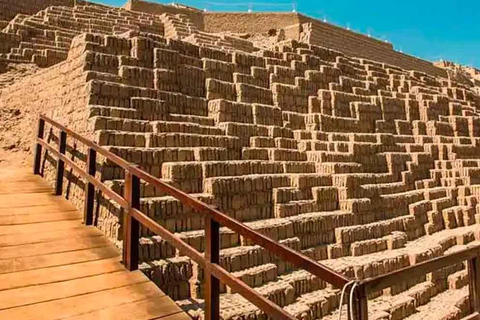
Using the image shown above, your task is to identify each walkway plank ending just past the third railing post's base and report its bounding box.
[0,225,102,247]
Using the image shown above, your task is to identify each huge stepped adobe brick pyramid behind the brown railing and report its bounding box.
[0,1,480,320]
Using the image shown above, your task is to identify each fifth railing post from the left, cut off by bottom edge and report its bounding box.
[205,216,220,320]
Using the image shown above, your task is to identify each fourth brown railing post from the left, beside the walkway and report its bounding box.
[123,170,140,271]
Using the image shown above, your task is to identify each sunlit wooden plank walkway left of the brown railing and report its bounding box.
[0,167,190,320]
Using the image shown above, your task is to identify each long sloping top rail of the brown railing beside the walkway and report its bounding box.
[40,115,350,288]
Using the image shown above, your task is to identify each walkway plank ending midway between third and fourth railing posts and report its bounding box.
[0,237,112,260]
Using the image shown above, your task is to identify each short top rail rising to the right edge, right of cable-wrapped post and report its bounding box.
[361,245,480,292]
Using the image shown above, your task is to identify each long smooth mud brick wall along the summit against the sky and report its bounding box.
[125,0,447,77]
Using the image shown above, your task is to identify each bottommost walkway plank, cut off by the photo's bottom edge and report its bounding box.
[60,296,182,320]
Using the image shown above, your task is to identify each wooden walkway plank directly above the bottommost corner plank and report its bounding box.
[0,282,163,320]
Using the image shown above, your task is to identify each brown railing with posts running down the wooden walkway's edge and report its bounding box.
[34,115,350,320]
